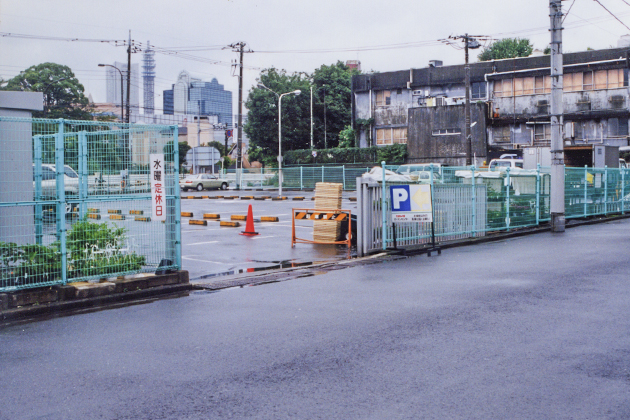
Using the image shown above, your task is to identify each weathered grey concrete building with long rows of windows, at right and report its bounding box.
[352,48,630,165]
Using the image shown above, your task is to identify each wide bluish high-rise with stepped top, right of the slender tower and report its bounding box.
[163,71,232,126]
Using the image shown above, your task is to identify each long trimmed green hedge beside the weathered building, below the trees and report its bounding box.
[283,144,407,165]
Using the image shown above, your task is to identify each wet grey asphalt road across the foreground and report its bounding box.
[0,220,630,420]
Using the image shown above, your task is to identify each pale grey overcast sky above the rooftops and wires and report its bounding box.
[0,0,630,113]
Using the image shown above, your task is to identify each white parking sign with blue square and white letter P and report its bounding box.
[390,184,433,223]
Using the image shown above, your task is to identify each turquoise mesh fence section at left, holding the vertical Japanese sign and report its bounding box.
[0,117,181,291]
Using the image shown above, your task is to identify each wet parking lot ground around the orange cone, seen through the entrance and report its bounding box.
[181,190,357,281]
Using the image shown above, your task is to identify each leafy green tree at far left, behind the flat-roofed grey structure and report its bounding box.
[2,63,92,120]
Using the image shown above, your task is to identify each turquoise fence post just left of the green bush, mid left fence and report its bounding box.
[55,118,68,283]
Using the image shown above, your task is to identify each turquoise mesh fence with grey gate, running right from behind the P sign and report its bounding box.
[358,164,630,255]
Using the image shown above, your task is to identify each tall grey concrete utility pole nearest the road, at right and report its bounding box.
[549,0,565,232]
